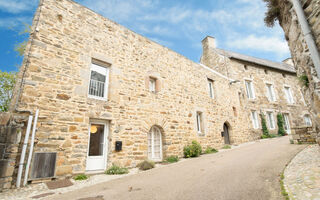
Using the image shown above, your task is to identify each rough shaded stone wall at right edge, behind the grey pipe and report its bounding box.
[279,0,320,144]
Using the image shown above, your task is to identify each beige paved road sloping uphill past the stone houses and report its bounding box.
[50,137,305,200]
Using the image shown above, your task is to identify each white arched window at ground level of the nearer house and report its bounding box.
[148,126,162,161]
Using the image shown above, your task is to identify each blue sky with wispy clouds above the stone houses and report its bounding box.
[0,0,290,71]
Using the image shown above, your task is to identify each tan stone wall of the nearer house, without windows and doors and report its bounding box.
[10,0,252,176]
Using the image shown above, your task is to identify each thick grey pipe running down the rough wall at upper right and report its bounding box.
[291,0,320,78]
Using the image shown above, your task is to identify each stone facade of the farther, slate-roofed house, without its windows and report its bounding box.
[201,40,309,136]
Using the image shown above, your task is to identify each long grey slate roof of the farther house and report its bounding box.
[212,48,296,73]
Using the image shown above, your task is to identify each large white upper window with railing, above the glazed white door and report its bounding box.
[89,63,109,99]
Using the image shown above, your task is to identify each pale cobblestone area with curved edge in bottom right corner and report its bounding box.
[284,145,320,200]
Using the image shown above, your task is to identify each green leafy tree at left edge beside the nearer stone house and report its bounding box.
[0,70,16,112]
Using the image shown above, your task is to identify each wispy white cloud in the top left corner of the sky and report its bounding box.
[0,0,38,14]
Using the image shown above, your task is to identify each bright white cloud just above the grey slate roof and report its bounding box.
[227,34,289,57]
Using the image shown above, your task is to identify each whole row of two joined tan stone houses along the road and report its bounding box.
[1,0,308,189]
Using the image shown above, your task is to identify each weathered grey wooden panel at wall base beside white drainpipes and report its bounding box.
[31,152,57,179]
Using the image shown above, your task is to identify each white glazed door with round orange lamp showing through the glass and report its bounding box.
[86,123,108,170]
